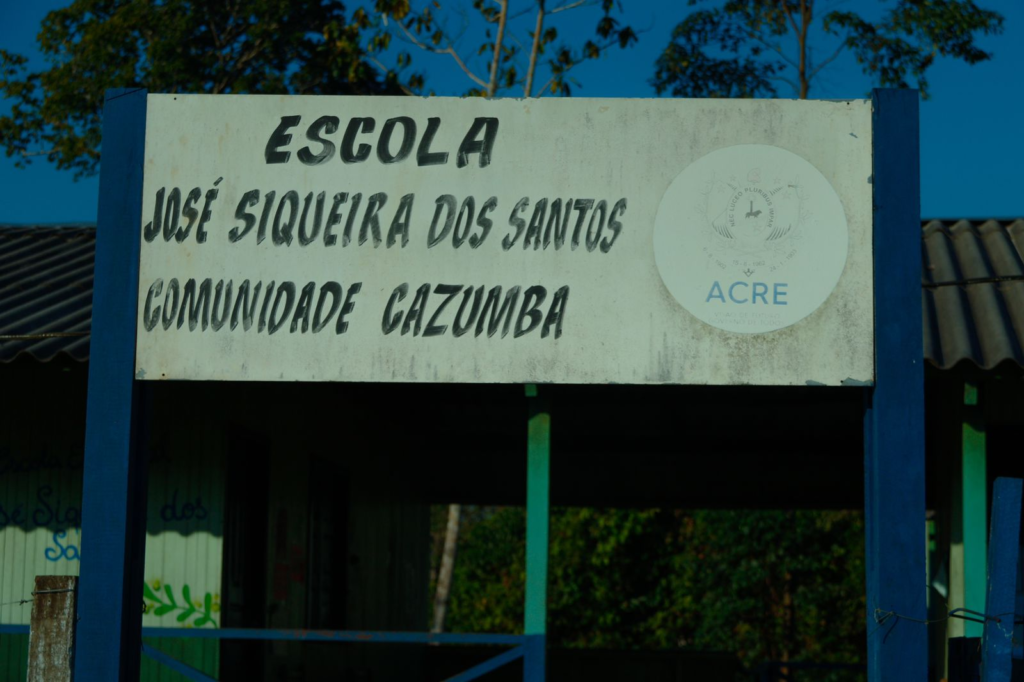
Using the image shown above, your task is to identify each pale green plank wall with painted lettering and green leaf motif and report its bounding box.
[0,374,224,682]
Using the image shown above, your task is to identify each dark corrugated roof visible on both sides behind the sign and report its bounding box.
[0,219,1024,370]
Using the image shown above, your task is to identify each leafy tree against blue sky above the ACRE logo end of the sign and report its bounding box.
[651,0,1002,99]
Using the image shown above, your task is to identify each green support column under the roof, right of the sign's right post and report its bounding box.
[961,382,988,637]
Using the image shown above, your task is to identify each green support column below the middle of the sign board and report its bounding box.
[523,385,551,682]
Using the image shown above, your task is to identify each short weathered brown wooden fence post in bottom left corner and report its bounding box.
[29,576,78,682]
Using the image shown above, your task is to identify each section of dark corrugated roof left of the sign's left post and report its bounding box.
[0,226,96,363]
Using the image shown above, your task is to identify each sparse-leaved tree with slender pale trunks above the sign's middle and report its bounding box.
[372,0,637,97]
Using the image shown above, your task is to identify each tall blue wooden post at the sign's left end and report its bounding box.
[75,88,146,682]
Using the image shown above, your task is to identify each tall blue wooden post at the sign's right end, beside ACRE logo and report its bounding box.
[864,89,928,682]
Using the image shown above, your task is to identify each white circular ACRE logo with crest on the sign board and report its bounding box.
[654,144,849,334]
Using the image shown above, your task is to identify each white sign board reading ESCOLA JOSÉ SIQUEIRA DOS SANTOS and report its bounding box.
[136,95,874,386]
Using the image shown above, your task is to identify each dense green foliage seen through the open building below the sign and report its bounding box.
[436,508,864,668]
